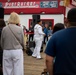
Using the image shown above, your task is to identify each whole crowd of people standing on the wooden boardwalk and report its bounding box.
[0,8,76,75]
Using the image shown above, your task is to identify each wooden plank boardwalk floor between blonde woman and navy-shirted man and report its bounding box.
[24,45,45,75]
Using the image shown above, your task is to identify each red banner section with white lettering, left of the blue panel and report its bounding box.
[2,2,40,8]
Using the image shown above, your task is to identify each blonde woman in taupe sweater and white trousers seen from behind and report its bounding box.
[1,12,24,75]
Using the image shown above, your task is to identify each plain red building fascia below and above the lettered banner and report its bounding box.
[0,0,65,14]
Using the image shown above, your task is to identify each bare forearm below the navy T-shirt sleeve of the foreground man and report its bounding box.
[46,54,54,75]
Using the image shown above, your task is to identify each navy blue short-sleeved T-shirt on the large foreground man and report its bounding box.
[45,27,76,75]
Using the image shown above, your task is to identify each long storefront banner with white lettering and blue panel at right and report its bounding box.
[2,0,58,9]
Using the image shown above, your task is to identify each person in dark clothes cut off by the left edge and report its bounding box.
[0,19,6,75]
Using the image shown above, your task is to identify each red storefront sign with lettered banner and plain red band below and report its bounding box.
[0,0,65,14]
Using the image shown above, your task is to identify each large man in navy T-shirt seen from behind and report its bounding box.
[45,8,76,75]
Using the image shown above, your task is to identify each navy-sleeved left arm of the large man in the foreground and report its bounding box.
[45,36,56,75]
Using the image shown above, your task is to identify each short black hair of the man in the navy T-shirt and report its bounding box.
[67,8,76,22]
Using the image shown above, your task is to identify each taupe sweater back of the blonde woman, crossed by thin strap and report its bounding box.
[2,24,23,50]
